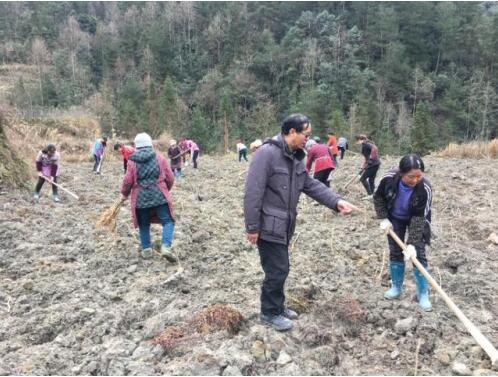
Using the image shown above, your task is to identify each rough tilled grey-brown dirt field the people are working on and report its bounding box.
[0,154,498,375]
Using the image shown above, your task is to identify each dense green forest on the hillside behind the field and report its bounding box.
[0,2,498,154]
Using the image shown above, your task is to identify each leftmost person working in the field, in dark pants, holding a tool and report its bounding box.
[33,144,60,203]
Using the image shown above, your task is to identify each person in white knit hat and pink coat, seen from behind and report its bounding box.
[121,133,178,262]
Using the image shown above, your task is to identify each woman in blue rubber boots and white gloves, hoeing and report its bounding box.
[374,154,432,311]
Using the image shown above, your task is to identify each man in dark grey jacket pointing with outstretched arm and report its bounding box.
[244,114,357,331]
